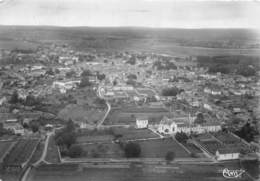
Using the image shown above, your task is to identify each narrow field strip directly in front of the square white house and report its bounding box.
[113,128,159,141]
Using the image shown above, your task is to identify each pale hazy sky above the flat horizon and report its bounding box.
[0,0,260,29]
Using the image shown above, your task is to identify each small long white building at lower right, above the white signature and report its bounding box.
[216,148,240,161]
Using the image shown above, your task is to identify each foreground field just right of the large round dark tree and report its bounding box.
[133,138,189,158]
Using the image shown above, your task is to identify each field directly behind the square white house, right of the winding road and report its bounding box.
[104,107,170,125]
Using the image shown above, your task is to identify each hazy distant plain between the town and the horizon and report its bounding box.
[0,26,260,55]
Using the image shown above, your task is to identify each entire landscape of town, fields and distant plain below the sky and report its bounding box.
[0,0,260,181]
